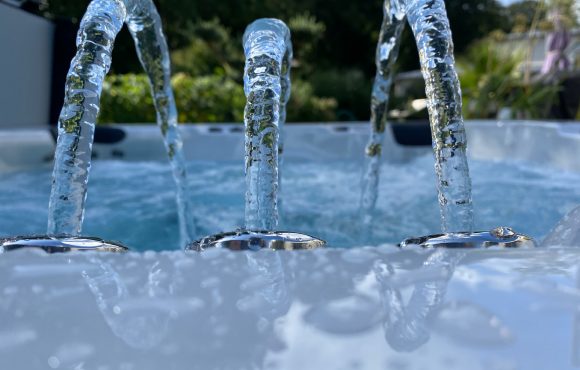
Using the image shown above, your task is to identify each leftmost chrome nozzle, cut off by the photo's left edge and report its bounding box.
[0,235,129,253]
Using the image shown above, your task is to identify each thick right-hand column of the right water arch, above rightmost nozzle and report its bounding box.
[407,0,473,232]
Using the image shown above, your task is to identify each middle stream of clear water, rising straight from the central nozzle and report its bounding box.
[243,19,292,230]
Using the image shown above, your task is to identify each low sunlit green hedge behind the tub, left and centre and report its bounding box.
[99,73,337,123]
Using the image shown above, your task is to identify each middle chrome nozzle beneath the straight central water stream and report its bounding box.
[186,229,326,252]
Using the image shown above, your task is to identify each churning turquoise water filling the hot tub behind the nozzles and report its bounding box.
[0,155,580,250]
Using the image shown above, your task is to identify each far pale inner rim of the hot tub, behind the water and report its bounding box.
[0,120,580,172]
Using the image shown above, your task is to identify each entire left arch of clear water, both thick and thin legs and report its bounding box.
[48,0,195,249]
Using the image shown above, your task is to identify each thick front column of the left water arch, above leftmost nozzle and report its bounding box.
[48,1,127,235]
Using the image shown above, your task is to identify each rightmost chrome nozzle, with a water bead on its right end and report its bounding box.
[399,226,537,249]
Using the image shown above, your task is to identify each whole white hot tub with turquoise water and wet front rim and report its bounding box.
[0,121,580,370]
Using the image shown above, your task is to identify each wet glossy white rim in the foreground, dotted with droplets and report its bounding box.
[0,246,580,370]
